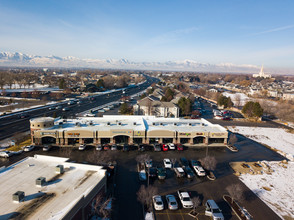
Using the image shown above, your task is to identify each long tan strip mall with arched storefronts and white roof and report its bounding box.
[30,115,228,146]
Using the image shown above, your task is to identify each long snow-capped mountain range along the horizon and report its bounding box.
[0,52,259,73]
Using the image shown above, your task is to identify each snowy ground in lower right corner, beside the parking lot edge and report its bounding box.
[240,162,294,219]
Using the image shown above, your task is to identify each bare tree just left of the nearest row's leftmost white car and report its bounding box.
[137,185,158,211]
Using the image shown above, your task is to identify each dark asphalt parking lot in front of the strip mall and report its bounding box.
[0,135,284,220]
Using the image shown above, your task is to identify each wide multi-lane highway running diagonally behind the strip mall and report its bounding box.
[0,76,158,140]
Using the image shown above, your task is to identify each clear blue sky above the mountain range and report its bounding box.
[0,0,294,68]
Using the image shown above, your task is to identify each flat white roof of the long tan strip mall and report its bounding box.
[39,115,227,133]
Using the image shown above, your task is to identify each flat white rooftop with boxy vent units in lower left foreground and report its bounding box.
[0,155,105,219]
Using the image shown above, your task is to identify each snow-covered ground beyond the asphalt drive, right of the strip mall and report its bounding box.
[228,126,294,161]
